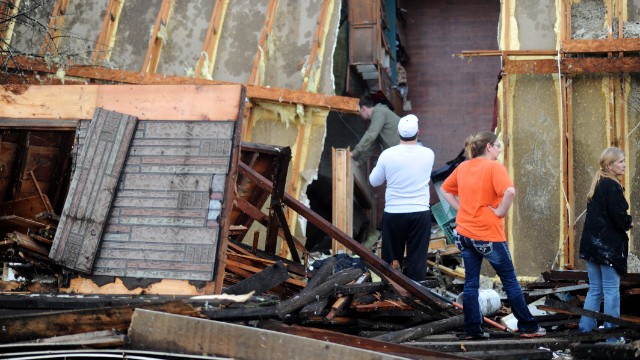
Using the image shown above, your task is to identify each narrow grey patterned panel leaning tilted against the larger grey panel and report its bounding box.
[49,109,137,273]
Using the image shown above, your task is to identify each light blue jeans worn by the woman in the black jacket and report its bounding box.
[578,261,620,332]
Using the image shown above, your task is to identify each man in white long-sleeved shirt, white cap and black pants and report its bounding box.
[369,115,435,281]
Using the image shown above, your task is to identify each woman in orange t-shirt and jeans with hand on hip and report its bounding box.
[442,132,546,339]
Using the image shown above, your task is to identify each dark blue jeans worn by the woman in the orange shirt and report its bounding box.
[454,234,538,335]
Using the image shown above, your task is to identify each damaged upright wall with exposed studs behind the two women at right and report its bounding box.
[499,0,640,276]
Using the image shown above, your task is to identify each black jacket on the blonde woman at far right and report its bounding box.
[580,178,631,275]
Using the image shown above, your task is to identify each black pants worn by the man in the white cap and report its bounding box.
[382,210,431,281]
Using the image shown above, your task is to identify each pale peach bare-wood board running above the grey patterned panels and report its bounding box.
[0,85,243,121]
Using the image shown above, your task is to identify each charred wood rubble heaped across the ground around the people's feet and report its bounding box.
[0,116,640,359]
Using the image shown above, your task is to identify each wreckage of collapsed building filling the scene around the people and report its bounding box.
[0,0,640,359]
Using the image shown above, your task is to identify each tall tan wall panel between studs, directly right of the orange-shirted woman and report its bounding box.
[508,75,562,275]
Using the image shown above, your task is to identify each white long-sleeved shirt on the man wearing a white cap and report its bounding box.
[369,144,435,213]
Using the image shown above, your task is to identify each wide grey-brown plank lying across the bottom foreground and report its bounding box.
[129,309,408,360]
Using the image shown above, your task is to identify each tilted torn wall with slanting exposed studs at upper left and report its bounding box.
[0,0,357,262]
